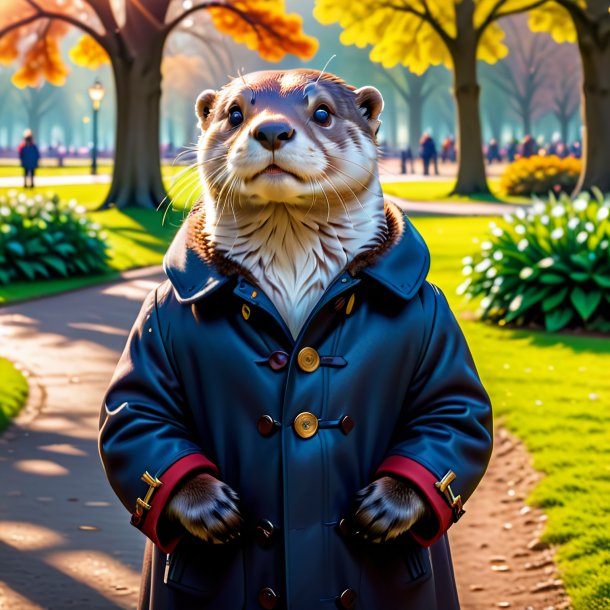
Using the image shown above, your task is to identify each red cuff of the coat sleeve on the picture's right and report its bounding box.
[376,455,453,546]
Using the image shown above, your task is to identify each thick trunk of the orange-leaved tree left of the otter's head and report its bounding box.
[102,45,165,209]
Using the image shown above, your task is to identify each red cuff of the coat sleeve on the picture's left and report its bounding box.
[131,453,218,553]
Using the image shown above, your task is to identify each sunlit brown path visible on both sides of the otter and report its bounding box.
[0,269,567,610]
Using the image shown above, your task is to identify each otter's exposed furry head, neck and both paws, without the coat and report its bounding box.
[167,70,428,543]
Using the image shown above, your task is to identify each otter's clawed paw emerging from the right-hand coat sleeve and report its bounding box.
[351,477,429,542]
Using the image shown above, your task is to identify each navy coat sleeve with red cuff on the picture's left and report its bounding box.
[99,284,218,552]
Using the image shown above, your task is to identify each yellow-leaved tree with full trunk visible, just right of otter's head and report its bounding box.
[314,0,547,195]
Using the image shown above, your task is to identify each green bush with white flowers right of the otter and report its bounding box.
[458,190,610,332]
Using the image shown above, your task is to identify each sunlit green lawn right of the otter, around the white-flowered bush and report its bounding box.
[414,218,610,610]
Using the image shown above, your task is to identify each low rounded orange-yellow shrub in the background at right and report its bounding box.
[500,155,582,197]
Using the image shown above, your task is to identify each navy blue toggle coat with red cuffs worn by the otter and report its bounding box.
[100,206,492,610]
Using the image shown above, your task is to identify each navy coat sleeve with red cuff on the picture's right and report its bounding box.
[377,283,493,546]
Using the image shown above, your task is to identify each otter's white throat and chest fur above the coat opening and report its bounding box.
[206,201,387,337]
